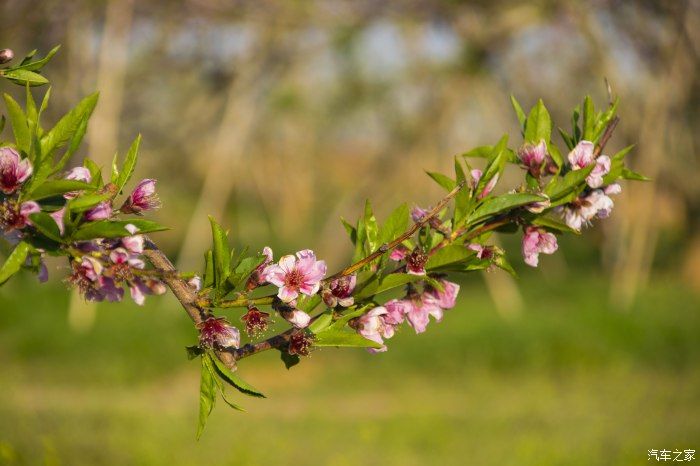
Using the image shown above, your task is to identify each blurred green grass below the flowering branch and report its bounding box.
[0,271,700,465]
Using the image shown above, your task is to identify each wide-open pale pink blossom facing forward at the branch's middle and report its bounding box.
[262,249,326,303]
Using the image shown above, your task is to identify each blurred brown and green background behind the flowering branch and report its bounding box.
[0,0,700,465]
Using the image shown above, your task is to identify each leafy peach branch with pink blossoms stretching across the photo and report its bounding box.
[0,49,645,437]
